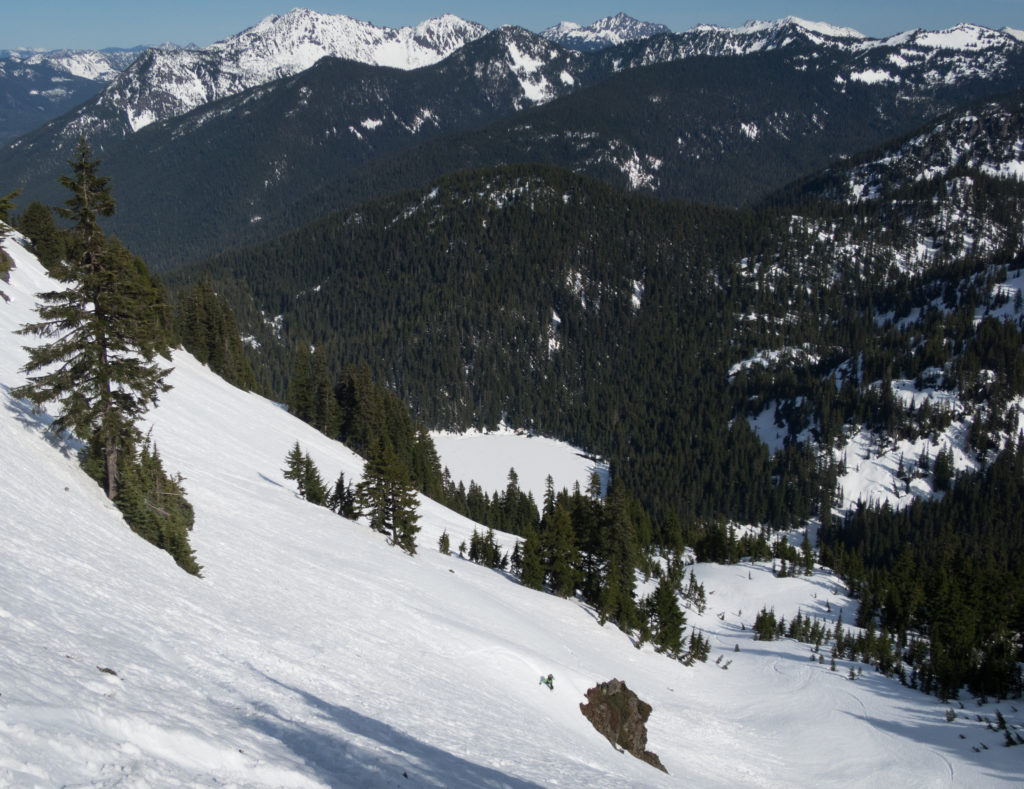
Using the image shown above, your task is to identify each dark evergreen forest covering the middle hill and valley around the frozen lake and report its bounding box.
[163,136,1024,695]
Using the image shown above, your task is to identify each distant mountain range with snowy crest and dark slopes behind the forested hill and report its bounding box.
[0,10,1024,268]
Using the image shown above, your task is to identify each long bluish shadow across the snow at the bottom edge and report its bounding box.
[243,669,541,789]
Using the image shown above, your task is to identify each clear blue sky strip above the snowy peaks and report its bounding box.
[6,0,1024,49]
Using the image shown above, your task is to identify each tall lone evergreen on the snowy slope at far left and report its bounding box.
[13,140,169,499]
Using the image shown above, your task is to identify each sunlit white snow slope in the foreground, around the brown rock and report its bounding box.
[0,240,1024,789]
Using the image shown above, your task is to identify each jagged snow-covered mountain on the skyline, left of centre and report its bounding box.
[76,9,486,136]
